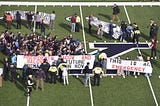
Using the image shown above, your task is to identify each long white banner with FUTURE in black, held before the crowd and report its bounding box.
[17,55,95,69]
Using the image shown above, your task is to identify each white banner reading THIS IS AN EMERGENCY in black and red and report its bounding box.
[107,58,152,73]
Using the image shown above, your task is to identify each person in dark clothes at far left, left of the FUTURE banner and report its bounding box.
[3,57,9,81]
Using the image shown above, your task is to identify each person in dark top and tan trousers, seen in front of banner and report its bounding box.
[36,68,46,91]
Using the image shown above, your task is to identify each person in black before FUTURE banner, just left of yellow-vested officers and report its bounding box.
[40,58,50,82]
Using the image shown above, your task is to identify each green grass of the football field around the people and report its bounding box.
[0,0,160,106]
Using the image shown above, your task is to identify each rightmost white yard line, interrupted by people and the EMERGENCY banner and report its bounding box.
[124,6,158,106]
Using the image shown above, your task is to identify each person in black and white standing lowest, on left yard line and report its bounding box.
[26,75,34,96]
